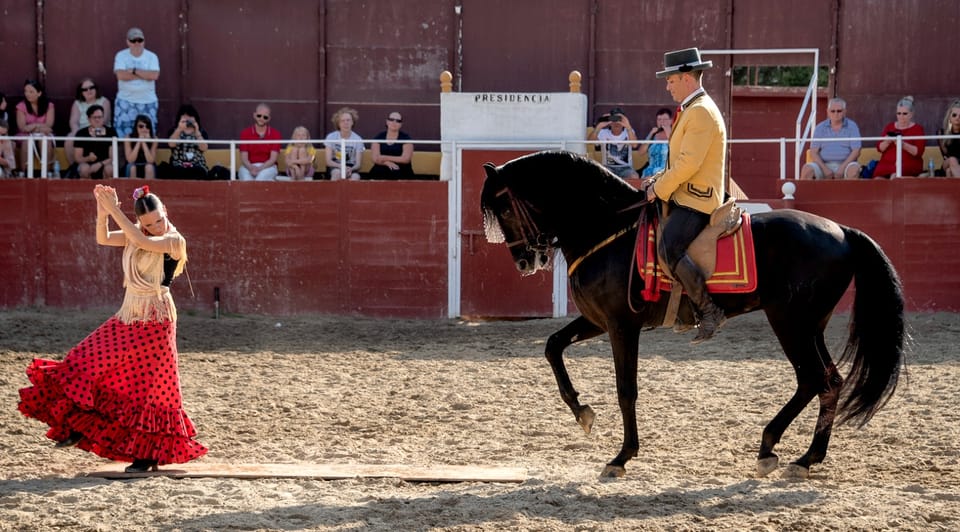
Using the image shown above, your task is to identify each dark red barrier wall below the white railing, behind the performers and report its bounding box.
[0,179,960,318]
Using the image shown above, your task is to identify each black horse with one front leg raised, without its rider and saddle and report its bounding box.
[481,152,904,477]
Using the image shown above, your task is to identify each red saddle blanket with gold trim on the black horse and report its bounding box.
[637,212,757,301]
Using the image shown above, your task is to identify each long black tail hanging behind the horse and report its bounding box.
[837,227,905,426]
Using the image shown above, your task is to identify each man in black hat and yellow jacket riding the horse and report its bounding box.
[641,48,727,344]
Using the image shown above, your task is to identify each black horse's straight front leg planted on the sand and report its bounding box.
[601,326,640,477]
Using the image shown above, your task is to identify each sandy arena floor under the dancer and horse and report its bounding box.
[0,310,960,532]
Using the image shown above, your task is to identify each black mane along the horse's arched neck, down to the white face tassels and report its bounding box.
[481,151,643,243]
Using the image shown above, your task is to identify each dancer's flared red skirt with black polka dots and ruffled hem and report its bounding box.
[19,317,207,465]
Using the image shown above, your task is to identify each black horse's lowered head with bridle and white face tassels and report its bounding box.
[480,163,556,275]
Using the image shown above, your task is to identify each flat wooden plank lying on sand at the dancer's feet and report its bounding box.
[81,462,527,482]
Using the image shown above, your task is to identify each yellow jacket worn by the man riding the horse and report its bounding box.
[653,93,727,214]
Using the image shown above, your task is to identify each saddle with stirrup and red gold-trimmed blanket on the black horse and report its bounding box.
[636,199,757,331]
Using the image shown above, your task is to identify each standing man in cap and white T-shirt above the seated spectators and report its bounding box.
[113,28,160,138]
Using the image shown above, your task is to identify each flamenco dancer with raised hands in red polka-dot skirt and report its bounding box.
[19,185,207,473]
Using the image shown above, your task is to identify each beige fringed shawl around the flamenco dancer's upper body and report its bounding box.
[116,224,187,323]
